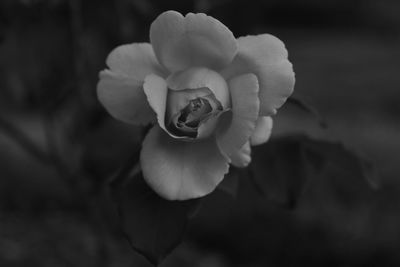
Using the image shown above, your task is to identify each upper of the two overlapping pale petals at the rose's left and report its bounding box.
[106,43,167,81]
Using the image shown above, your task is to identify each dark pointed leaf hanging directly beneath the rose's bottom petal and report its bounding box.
[114,174,200,266]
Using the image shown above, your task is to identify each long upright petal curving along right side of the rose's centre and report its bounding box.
[217,74,260,161]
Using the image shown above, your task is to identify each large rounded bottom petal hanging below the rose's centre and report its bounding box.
[140,126,229,200]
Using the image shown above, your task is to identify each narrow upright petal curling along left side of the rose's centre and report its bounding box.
[143,74,168,132]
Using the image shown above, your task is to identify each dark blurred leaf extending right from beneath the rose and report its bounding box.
[251,136,378,208]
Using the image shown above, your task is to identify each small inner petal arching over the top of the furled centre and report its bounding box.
[167,67,230,109]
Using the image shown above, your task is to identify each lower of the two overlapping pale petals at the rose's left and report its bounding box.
[97,70,155,124]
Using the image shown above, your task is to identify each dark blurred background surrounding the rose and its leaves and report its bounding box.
[0,0,400,267]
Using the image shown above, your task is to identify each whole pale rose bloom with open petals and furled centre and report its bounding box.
[97,11,295,200]
